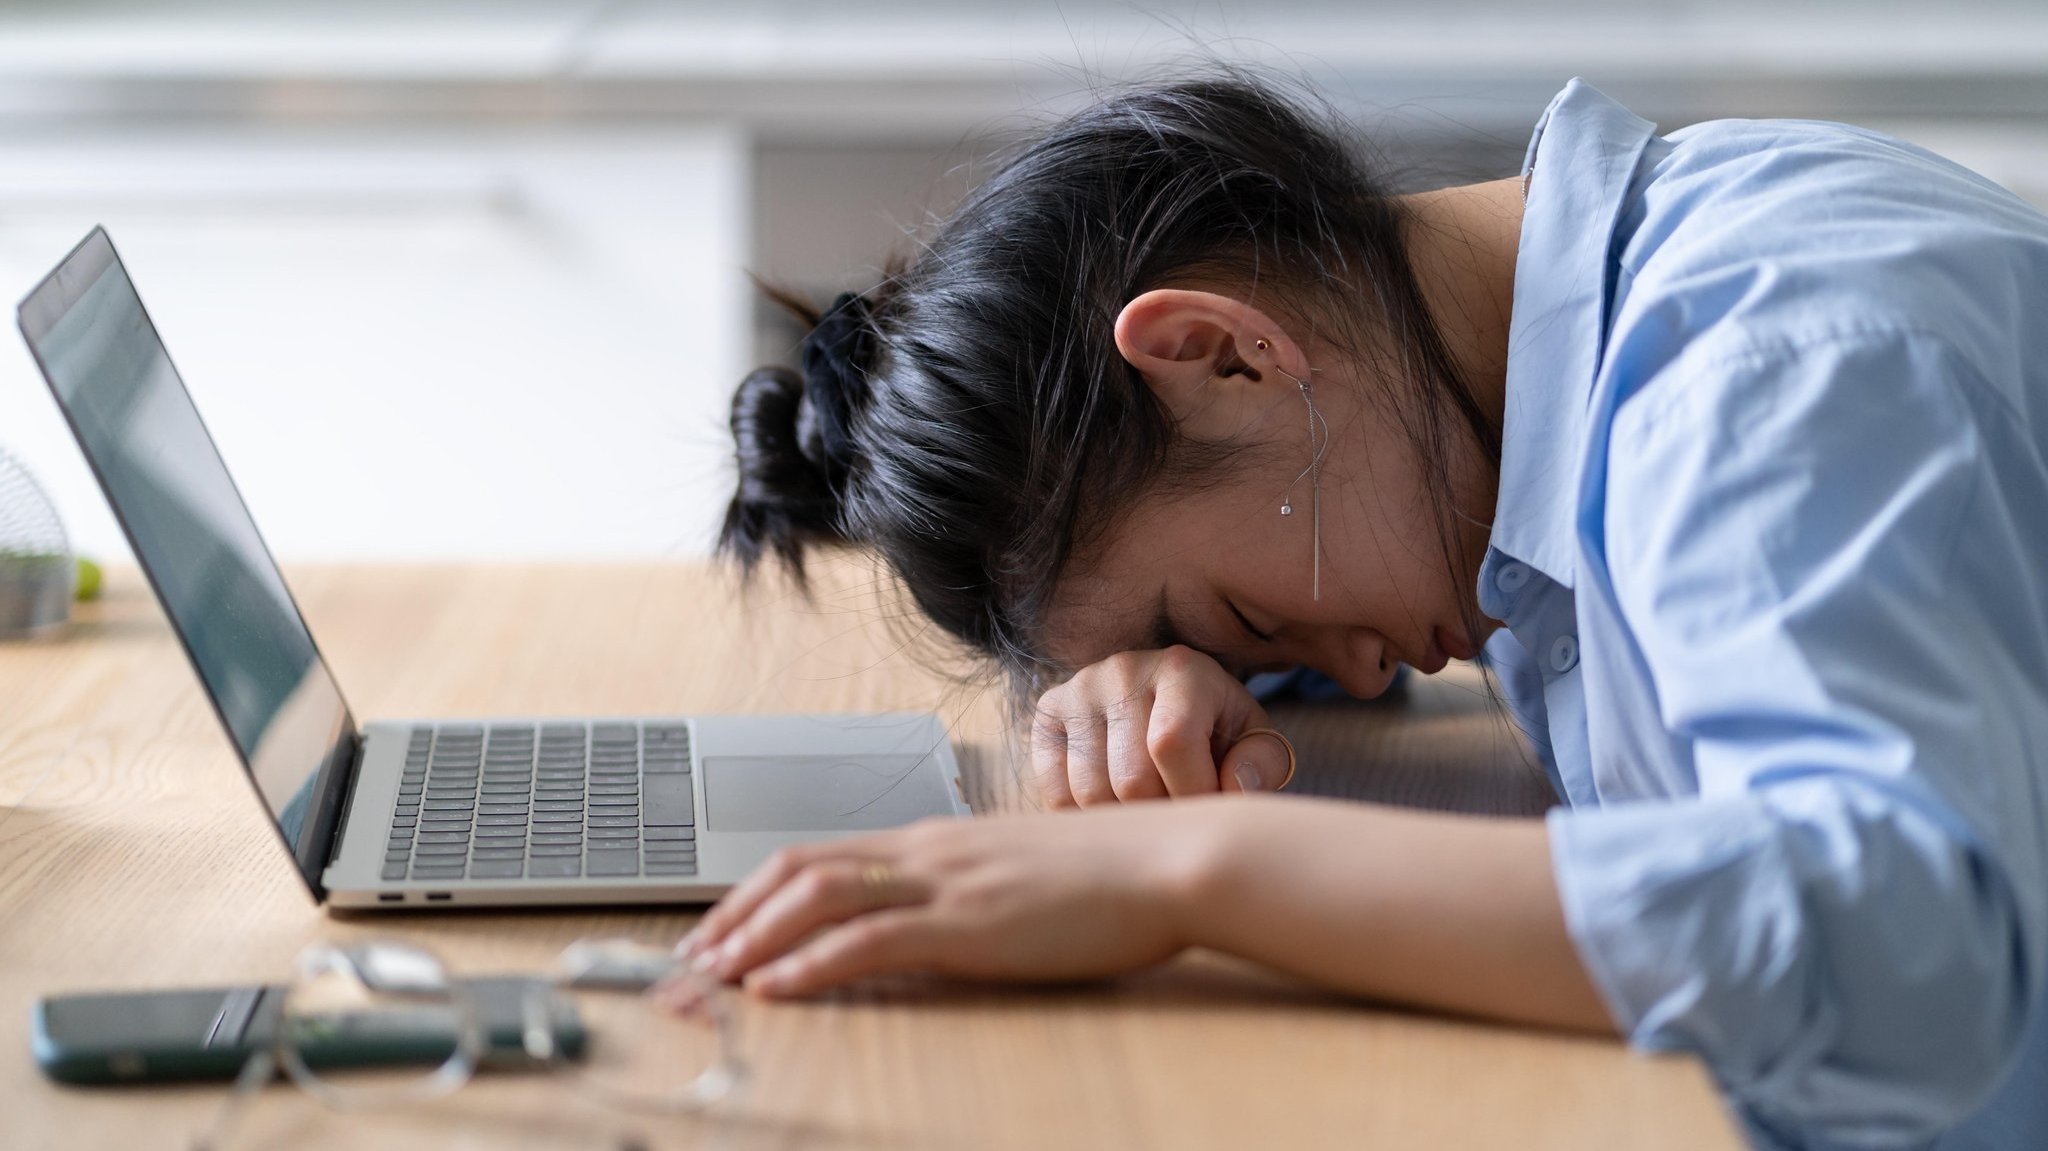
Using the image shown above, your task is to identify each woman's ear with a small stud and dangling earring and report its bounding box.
[1116,289,1307,438]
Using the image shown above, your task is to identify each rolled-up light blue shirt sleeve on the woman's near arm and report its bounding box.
[1550,332,2048,1147]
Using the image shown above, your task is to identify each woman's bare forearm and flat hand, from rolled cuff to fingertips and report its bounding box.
[657,797,1614,1034]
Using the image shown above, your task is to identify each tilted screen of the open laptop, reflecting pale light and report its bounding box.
[20,229,354,897]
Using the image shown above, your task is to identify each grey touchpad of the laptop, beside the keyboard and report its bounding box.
[705,756,952,832]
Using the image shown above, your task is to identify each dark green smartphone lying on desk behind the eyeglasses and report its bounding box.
[29,975,584,1083]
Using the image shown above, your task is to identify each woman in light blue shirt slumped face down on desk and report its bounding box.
[688,80,2048,1149]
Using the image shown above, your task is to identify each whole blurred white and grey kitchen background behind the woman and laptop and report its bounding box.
[0,0,2048,559]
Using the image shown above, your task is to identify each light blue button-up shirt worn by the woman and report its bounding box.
[1479,82,2048,1151]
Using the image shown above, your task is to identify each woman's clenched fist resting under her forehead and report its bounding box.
[1032,647,1288,807]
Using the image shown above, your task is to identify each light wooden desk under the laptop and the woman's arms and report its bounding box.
[0,565,1741,1151]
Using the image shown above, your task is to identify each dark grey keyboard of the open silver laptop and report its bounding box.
[383,723,696,881]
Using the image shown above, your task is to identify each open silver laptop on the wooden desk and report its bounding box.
[16,227,969,909]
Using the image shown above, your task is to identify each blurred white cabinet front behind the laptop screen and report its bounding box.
[0,125,748,557]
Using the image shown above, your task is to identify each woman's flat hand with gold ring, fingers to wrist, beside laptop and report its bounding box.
[667,803,1212,995]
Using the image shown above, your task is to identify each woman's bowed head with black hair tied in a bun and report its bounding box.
[719,78,1497,690]
